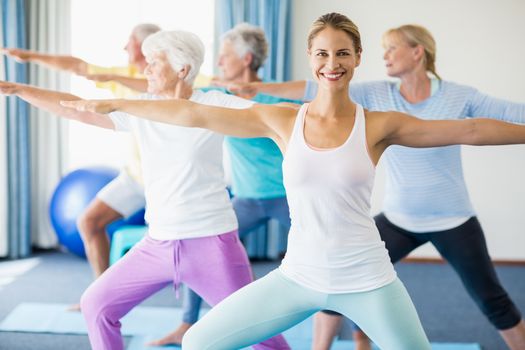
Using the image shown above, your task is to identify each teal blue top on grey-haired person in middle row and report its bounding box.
[203,88,302,199]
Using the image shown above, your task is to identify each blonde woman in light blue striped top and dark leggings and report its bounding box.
[304,25,525,350]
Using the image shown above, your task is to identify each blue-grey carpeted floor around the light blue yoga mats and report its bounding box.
[0,251,525,350]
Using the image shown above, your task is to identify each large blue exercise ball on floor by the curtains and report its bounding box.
[49,167,144,258]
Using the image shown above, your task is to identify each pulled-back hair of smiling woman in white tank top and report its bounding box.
[308,12,363,54]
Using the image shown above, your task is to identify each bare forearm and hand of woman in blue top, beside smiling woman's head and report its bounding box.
[212,80,306,100]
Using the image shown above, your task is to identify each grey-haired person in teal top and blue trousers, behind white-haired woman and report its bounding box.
[150,23,300,346]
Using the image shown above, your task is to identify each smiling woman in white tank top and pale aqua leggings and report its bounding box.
[59,13,525,350]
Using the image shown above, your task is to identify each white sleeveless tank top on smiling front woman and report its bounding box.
[279,104,396,293]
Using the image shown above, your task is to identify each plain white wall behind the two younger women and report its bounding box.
[292,0,525,261]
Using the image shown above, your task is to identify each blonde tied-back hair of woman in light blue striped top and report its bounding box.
[383,24,441,80]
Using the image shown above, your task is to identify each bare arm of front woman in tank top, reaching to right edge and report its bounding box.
[376,112,525,147]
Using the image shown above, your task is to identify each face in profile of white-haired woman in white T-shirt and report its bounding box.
[144,52,181,95]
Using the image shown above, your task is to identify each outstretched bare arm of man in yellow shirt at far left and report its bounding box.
[1,48,88,75]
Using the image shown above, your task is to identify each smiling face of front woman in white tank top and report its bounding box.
[308,26,361,90]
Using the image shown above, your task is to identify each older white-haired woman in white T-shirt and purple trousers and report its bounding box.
[0,31,289,350]
